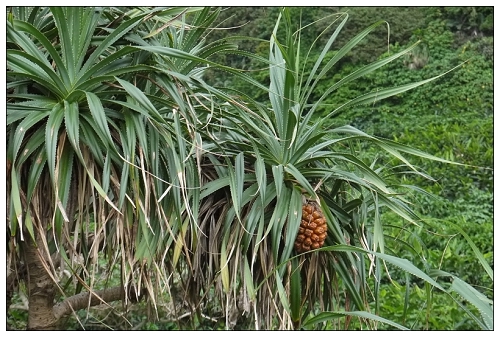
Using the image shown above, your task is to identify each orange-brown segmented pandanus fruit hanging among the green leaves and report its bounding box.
[295,201,327,253]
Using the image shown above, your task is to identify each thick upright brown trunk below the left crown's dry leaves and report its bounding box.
[24,235,57,330]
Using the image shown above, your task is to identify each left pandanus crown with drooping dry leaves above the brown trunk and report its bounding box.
[7,7,264,329]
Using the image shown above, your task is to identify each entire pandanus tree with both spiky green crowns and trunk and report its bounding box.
[7,7,491,329]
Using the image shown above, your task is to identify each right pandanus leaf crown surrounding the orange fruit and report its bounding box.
[177,9,491,329]
